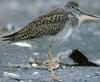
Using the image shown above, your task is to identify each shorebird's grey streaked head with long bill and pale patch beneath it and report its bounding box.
[66,0,98,22]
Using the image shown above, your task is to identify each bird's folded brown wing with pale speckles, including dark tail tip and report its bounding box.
[2,9,68,42]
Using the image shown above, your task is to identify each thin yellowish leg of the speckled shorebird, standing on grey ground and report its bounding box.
[48,45,58,80]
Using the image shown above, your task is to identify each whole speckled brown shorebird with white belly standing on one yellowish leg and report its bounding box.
[2,1,97,80]
